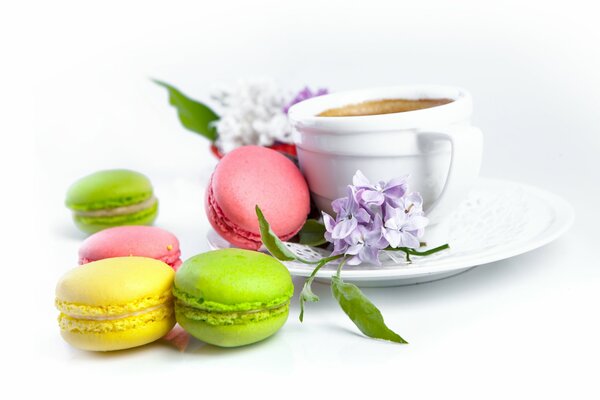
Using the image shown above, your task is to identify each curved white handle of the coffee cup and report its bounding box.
[419,126,483,223]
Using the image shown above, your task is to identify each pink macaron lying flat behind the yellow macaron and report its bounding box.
[79,225,181,270]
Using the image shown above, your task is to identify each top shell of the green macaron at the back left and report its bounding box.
[65,169,153,211]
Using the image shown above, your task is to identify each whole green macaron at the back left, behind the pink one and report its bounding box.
[65,169,158,233]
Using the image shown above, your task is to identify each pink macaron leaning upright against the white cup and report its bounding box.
[205,146,310,250]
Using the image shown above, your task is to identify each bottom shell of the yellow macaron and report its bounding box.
[60,314,175,351]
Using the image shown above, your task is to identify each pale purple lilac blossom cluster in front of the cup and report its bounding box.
[323,171,429,265]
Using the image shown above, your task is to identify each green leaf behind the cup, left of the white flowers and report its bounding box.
[154,80,219,142]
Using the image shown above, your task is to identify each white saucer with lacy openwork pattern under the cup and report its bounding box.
[208,178,574,287]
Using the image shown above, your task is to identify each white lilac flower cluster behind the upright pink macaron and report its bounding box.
[211,79,291,154]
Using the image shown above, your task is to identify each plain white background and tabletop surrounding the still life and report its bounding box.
[5,0,600,398]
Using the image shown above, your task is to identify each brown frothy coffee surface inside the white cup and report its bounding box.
[318,99,453,117]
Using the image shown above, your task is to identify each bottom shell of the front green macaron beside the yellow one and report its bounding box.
[175,308,289,347]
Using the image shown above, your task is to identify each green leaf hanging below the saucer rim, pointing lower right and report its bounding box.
[331,276,408,343]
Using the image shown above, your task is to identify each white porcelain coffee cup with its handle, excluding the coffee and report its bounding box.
[288,85,482,244]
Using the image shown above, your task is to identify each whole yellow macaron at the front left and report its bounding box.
[55,257,175,351]
